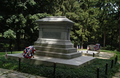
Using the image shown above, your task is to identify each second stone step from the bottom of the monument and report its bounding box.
[34,46,77,53]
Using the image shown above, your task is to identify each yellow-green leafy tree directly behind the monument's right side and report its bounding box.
[53,0,99,45]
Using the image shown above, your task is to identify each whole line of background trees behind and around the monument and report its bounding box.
[0,0,120,51]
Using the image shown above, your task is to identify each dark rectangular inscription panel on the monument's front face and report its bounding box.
[42,31,61,39]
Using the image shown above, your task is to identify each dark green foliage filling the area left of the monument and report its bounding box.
[0,0,51,49]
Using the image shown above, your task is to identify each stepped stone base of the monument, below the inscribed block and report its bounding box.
[34,38,81,59]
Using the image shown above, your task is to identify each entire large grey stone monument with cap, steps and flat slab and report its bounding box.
[7,16,95,68]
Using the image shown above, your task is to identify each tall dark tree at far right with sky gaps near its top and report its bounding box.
[96,0,116,49]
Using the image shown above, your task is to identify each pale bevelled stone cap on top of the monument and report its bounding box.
[36,16,74,24]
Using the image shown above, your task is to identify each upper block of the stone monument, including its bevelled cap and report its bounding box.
[36,16,74,40]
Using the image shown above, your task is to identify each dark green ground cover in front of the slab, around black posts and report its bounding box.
[0,51,120,78]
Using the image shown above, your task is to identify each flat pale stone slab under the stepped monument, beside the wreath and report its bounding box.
[8,53,95,68]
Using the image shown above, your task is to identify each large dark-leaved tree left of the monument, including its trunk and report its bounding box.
[1,0,47,50]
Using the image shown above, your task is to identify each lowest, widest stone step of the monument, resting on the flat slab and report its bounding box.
[35,51,82,59]
